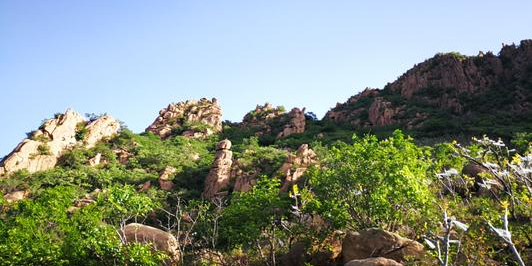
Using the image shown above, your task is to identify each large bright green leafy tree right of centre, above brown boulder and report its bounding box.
[309,131,433,230]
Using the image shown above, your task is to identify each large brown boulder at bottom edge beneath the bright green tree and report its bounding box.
[342,228,425,263]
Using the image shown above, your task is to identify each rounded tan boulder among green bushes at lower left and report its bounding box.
[121,223,179,261]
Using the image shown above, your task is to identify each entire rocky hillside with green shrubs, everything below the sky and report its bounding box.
[0,41,532,266]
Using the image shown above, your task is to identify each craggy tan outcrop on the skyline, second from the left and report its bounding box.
[146,98,222,139]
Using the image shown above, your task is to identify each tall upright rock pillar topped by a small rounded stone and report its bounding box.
[202,139,233,199]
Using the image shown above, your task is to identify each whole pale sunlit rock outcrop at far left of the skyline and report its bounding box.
[0,110,120,177]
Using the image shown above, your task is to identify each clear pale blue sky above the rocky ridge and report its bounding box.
[0,0,532,157]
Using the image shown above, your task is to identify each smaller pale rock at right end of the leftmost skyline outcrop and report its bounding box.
[84,115,120,148]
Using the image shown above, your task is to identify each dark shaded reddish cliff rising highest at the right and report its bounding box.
[325,40,532,135]
